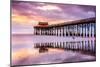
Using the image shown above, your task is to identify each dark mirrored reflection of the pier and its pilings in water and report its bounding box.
[34,40,96,54]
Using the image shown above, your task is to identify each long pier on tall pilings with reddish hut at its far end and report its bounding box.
[34,17,96,37]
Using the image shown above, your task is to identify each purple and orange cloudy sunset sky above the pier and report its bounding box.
[11,1,96,34]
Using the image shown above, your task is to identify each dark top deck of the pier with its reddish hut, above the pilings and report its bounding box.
[34,17,96,28]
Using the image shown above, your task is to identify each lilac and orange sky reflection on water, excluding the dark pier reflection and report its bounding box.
[12,35,95,65]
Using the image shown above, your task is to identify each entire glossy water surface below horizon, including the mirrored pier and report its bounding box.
[12,35,96,66]
